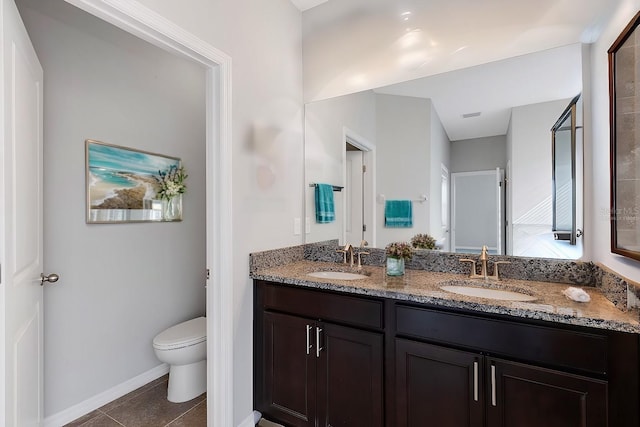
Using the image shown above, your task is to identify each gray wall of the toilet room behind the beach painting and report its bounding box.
[18,0,206,416]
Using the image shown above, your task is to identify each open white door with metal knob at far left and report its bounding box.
[0,0,44,427]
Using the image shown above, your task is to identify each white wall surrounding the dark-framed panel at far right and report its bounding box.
[585,0,640,281]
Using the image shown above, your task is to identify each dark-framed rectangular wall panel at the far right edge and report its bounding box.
[608,12,640,260]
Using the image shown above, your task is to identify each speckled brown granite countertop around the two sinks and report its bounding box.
[251,261,640,334]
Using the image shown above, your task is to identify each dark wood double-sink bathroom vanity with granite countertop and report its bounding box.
[252,261,640,427]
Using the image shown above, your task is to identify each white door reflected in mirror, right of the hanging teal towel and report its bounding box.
[344,151,364,246]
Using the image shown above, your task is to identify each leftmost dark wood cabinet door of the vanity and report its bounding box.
[260,312,316,427]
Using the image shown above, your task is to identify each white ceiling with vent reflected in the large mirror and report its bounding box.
[375,43,582,141]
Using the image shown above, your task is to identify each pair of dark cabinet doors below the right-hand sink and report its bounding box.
[396,339,607,427]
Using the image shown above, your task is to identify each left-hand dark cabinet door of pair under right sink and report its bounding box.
[395,339,484,427]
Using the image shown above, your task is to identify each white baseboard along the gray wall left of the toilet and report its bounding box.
[44,363,169,427]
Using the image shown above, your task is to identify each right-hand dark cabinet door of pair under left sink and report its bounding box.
[317,323,384,427]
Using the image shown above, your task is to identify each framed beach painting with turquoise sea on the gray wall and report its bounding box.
[85,139,182,223]
